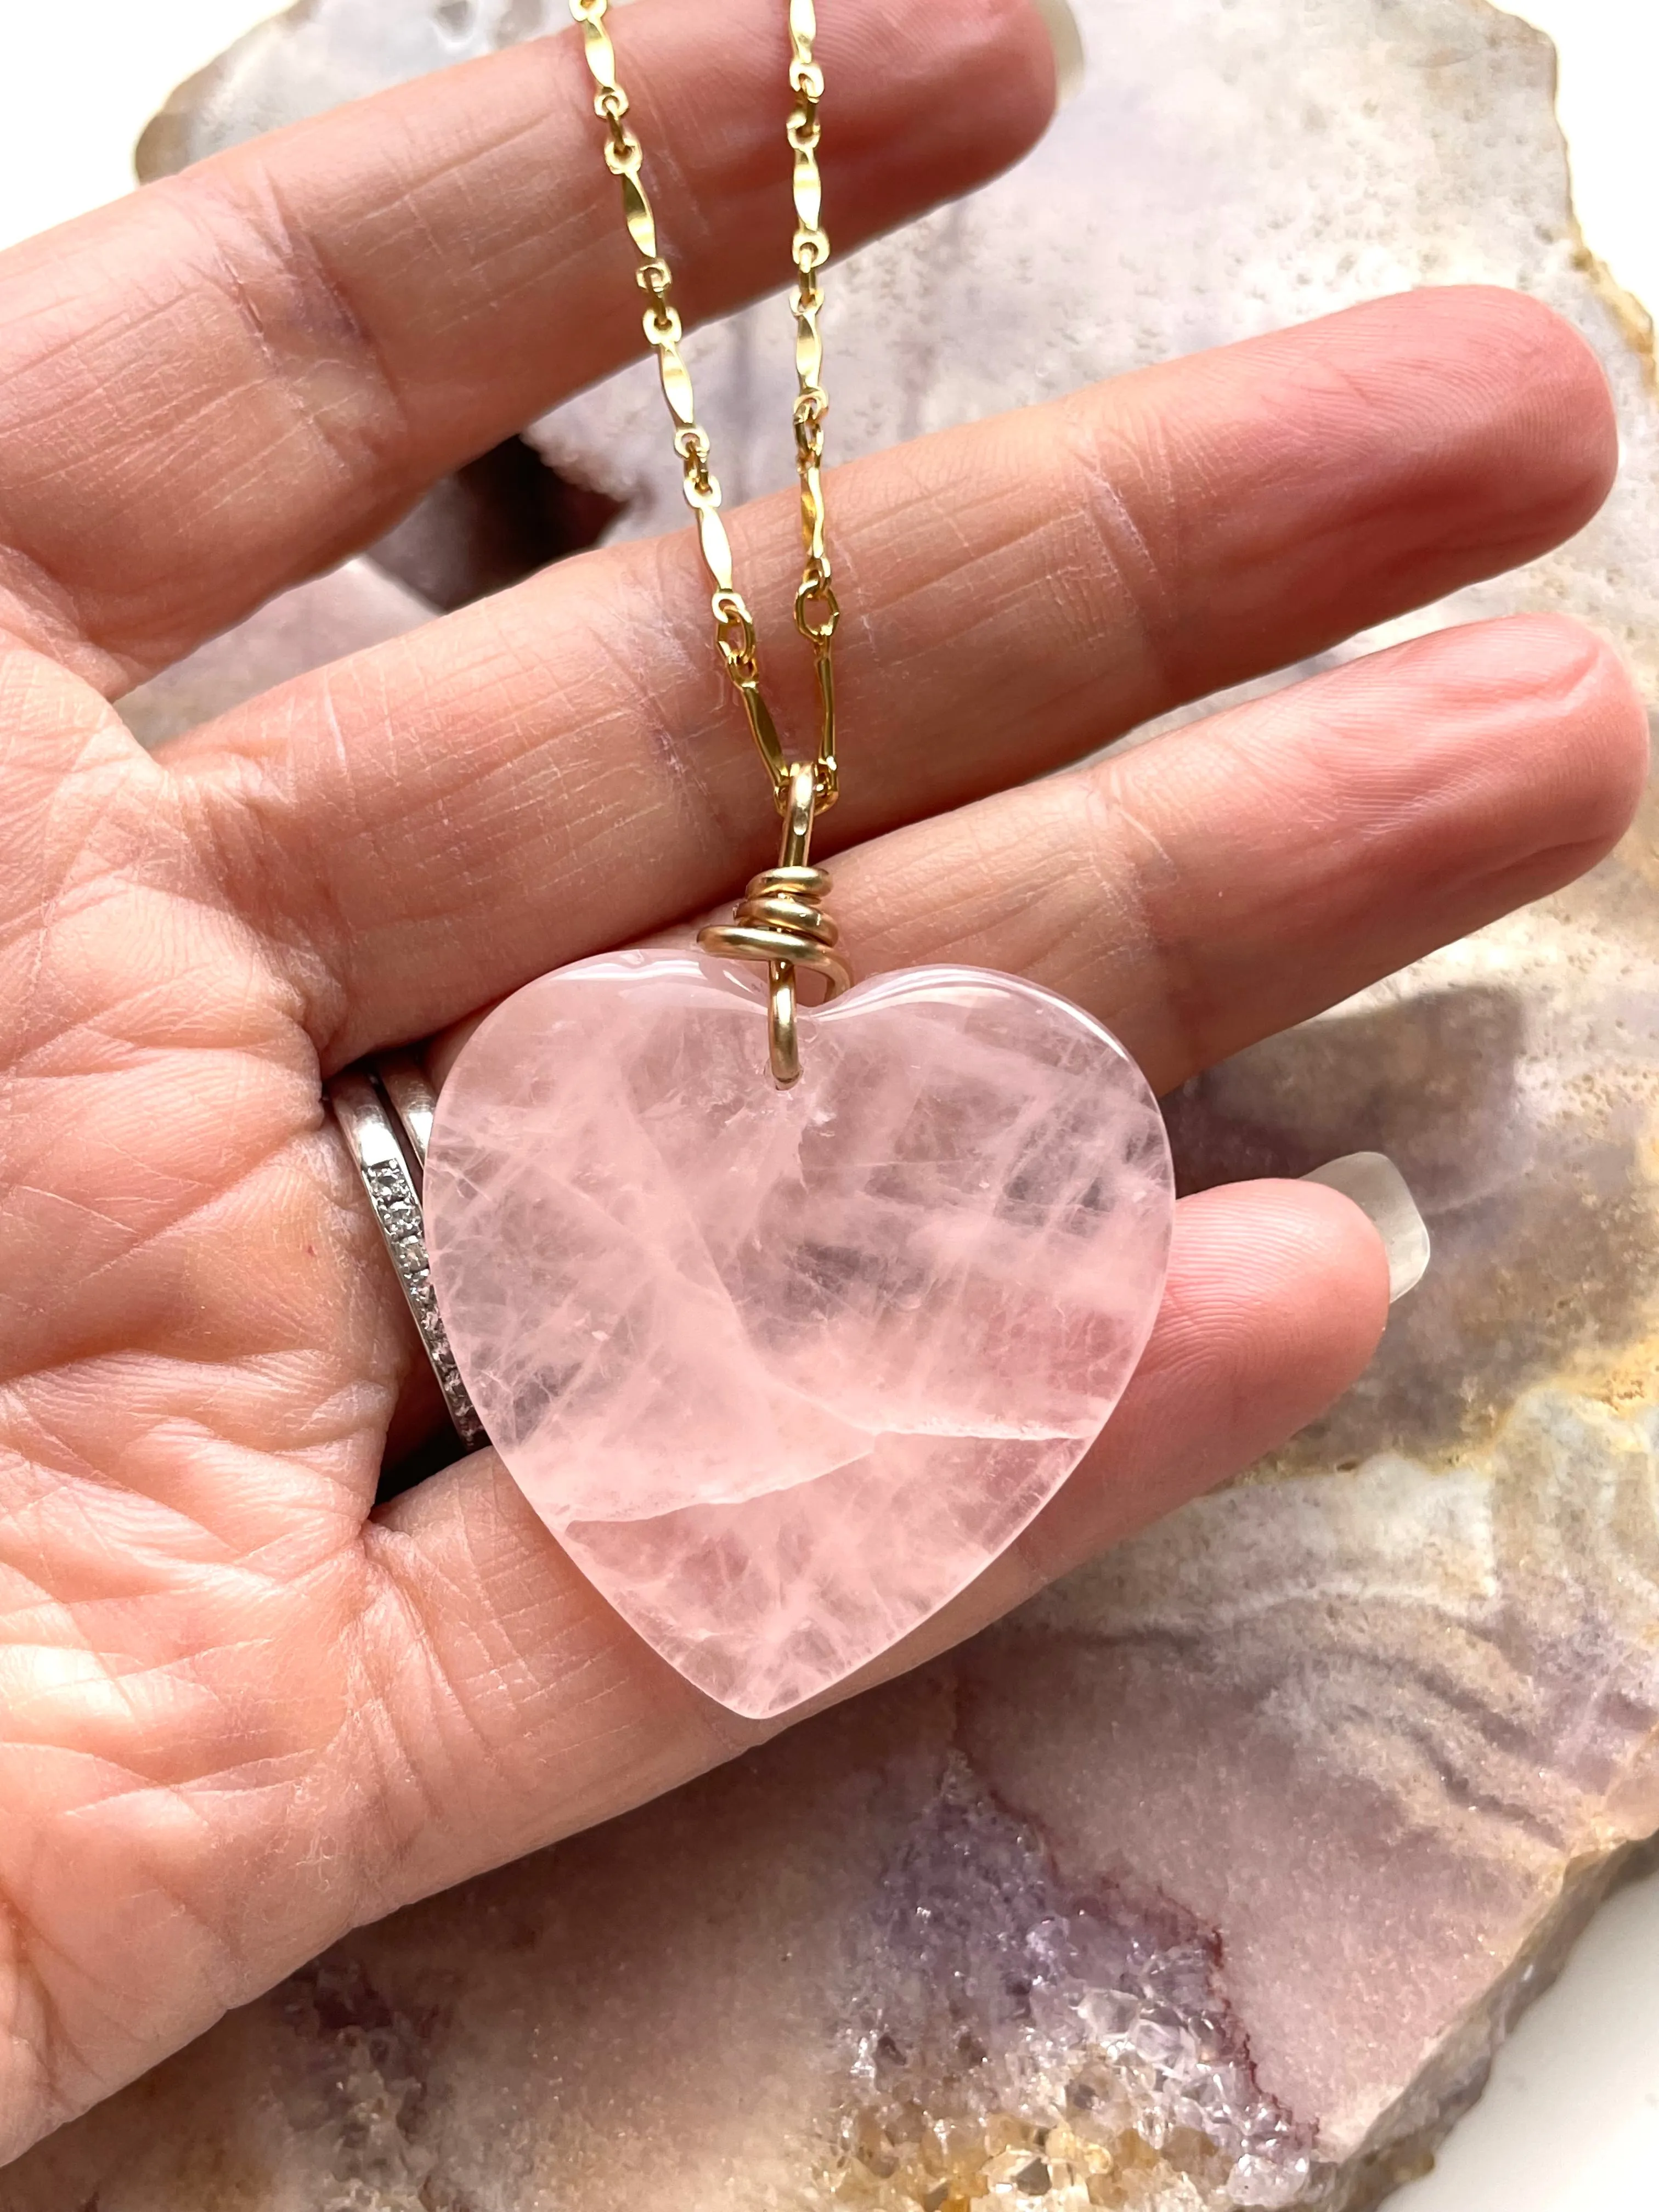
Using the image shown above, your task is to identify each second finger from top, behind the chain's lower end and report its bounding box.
[181,292,1612,1059]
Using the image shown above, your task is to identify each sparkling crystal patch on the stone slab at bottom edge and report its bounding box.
[825,1758,1314,2212]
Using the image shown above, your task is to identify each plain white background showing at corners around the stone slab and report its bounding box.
[0,0,1659,2212]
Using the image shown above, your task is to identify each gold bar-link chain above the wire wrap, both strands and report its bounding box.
[571,0,840,814]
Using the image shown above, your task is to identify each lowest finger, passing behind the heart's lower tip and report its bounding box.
[341,1183,1387,1914]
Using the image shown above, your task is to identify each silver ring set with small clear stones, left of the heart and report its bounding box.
[323,1053,489,1451]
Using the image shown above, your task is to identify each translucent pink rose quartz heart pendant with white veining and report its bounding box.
[425,951,1175,1717]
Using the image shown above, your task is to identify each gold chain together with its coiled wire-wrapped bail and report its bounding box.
[571,0,851,1086]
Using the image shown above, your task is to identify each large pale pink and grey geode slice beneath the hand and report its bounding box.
[16,0,1659,2212]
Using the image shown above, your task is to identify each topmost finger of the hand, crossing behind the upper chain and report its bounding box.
[0,0,1053,688]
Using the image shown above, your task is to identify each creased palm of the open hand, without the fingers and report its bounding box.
[0,648,398,2117]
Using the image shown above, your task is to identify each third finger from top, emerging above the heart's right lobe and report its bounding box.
[832,615,1648,1091]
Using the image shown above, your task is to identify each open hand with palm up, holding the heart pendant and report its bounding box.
[0,0,1646,2152]
